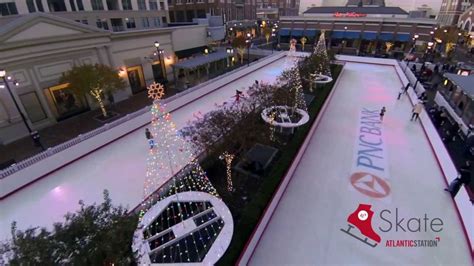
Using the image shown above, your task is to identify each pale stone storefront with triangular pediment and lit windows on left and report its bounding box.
[0,13,208,144]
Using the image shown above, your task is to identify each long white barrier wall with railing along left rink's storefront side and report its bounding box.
[0,52,285,199]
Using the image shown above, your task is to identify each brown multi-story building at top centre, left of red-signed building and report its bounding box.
[167,0,256,22]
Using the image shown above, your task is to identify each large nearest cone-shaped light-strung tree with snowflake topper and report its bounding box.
[142,83,217,218]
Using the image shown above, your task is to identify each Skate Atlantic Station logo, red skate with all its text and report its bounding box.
[341,204,443,248]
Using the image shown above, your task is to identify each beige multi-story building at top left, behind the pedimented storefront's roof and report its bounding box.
[0,0,169,32]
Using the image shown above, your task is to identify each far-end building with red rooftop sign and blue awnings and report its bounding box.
[279,7,436,57]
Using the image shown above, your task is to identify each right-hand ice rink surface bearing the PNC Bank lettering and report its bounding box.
[248,63,472,266]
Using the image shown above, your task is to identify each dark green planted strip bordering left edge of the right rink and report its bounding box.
[210,65,342,265]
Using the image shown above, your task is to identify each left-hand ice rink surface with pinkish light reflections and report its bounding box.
[0,57,286,240]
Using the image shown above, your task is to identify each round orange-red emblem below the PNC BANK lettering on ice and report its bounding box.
[351,172,390,198]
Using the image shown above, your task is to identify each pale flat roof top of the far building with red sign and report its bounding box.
[304,6,408,15]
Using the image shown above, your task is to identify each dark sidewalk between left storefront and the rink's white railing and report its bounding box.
[0,89,154,167]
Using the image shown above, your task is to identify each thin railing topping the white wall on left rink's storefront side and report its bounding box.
[0,53,284,179]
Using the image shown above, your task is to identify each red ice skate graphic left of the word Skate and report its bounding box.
[341,204,382,248]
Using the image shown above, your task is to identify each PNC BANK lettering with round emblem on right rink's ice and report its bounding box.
[350,108,390,198]
